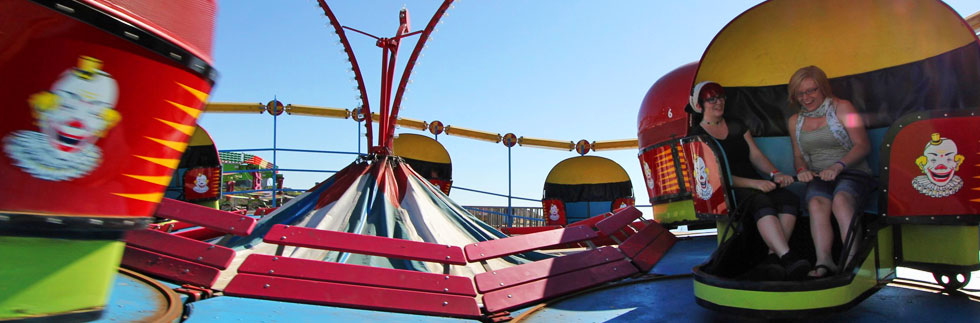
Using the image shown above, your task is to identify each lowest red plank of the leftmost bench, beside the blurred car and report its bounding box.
[122,246,220,287]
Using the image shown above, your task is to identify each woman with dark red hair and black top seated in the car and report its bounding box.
[690,82,810,280]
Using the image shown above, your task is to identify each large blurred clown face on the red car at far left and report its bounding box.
[4,56,120,181]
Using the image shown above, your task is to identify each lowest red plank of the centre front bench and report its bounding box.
[224,274,480,318]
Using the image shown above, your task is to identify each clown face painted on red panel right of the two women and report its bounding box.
[912,133,966,198]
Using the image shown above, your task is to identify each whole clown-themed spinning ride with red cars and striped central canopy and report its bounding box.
[0,0,980,322]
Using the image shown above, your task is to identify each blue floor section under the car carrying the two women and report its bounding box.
[515,277,980,322]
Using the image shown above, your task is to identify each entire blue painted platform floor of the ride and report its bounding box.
[100,236,980,323]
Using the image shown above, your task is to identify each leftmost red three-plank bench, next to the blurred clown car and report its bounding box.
[122,198,256,288]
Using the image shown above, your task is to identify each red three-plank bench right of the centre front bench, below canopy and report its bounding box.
[463,208,639,313]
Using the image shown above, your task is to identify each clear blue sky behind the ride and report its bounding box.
[200,0,980,210]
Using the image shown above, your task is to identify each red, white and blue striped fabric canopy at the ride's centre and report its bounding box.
[212,156,546,286]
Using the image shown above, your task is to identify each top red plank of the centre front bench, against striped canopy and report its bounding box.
[263,224,466,265]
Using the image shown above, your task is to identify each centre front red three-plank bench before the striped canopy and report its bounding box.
[224,224,482,318]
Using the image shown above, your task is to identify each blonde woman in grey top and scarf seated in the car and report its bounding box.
[787,66,871,277]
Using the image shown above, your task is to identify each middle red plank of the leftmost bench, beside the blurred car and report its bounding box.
[126,230,235,269]
